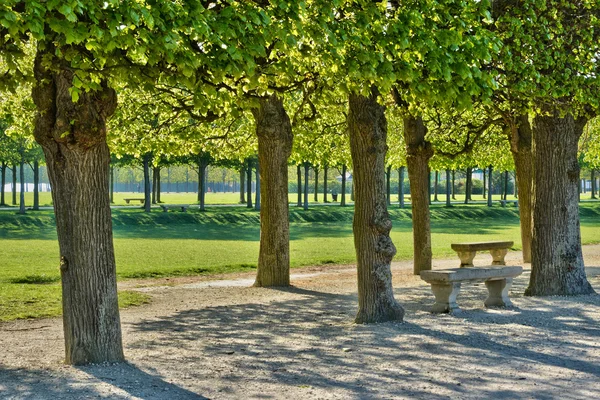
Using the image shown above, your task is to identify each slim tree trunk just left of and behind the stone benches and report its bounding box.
[404,116,433,275]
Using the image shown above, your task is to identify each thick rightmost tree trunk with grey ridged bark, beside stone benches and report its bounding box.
[525,113,594,296]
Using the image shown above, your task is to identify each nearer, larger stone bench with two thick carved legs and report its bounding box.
[421,266,523,314]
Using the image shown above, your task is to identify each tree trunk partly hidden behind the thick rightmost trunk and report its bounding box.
[509,115,533,263]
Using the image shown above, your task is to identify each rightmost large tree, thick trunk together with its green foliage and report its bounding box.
[494,0,600,295]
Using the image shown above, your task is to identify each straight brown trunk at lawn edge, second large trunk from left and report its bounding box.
[252,95,293,287]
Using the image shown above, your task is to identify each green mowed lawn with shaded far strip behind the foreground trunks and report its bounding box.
[0,202,600,321]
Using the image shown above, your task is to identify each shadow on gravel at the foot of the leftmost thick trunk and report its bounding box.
[0,363,206,400]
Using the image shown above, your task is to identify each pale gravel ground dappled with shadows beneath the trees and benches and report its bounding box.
[0,246,600,400]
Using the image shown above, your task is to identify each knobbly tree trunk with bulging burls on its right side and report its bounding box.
[348,93,404,324]
